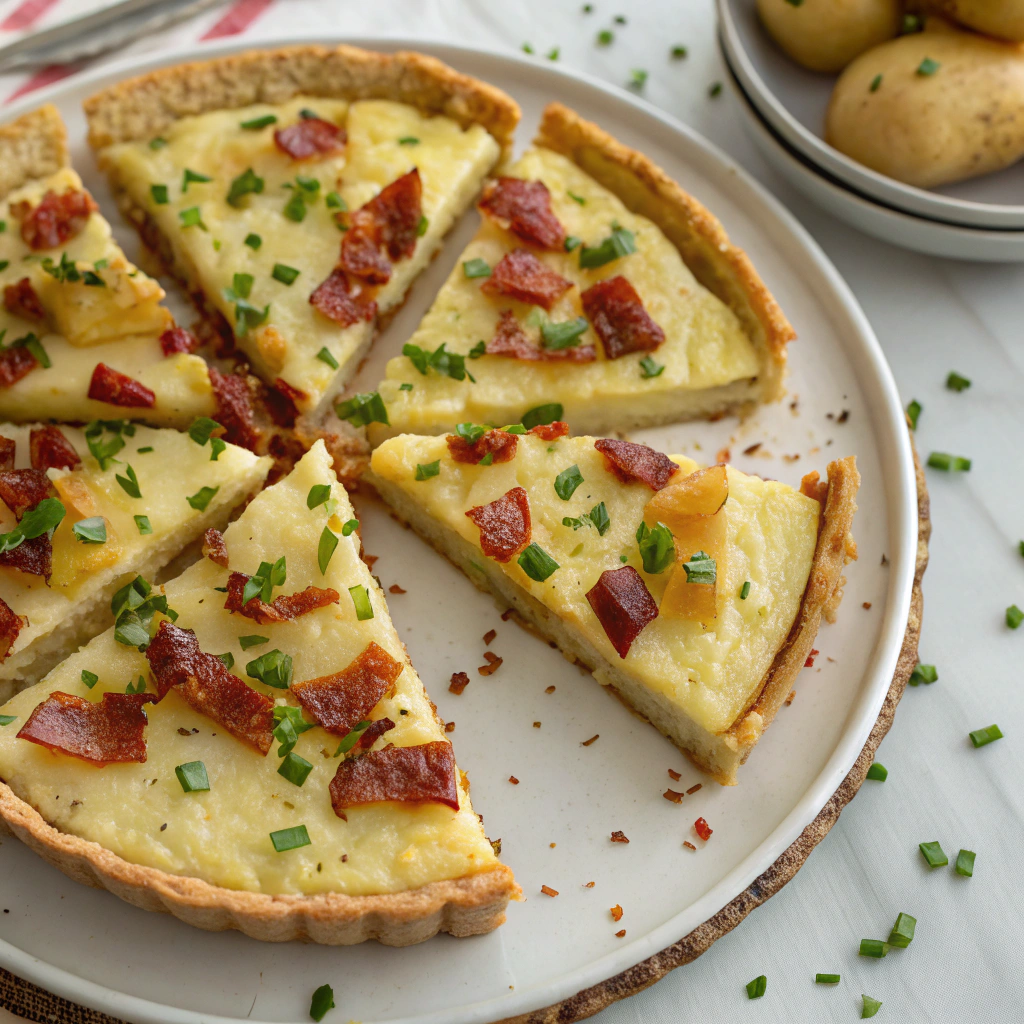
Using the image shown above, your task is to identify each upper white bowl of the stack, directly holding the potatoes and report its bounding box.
[716,0,1024,229]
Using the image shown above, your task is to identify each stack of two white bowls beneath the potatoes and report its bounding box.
[716,0,1024,262]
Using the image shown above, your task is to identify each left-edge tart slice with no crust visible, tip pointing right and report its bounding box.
[0,420,271,699]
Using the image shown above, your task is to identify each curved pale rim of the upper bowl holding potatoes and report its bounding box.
[715,0,1024,231]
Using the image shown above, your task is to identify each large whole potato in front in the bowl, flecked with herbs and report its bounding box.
[825,27,1024,188]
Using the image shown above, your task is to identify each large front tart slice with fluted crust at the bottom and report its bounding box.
[0,441,518,945]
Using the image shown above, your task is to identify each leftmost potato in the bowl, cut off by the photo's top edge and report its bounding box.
[758,0,902,72]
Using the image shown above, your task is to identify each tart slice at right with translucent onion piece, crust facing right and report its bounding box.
[368,423,859,785]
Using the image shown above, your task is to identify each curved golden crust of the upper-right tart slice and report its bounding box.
[534,103,797,401]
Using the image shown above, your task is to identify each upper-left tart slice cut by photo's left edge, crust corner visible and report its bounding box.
[0,106,217,427]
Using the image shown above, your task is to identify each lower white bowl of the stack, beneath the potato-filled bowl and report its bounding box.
[719,49,1024,263]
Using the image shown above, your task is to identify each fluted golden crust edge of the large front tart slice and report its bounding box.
[0,783,519,946]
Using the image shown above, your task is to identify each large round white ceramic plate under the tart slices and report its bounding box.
[0,34,916,1024]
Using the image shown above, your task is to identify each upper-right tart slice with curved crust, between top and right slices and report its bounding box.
[372,103,794,439]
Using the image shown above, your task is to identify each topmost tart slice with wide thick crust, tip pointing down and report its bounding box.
[85,46,519,422]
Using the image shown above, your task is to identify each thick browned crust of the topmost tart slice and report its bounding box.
[84,45,519,153]
